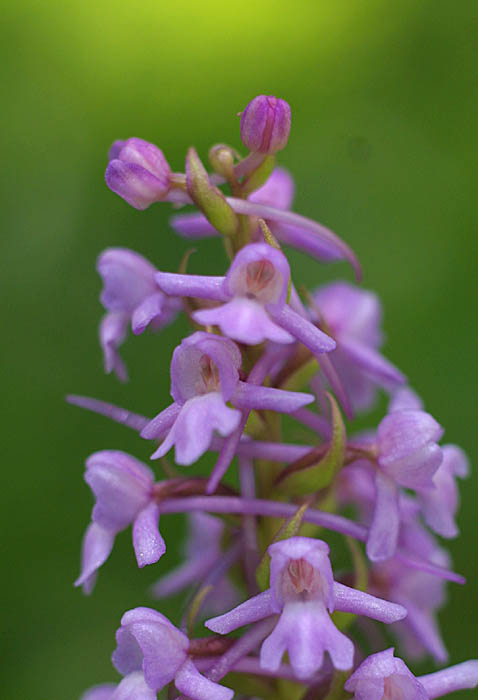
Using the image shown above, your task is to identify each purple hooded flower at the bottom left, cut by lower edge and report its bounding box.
[113,608,234,700]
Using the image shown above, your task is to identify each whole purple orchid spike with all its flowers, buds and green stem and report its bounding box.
[69,95,478,700]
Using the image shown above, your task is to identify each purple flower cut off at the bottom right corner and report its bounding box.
[344,649,478,700]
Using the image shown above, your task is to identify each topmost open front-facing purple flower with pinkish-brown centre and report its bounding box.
[156,243,335,355]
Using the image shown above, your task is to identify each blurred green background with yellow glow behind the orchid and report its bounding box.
[0,0,478,700]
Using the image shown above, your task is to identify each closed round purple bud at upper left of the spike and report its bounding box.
[105,138,171,209]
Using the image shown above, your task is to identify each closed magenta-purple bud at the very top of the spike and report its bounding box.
[241,95,291,154]
